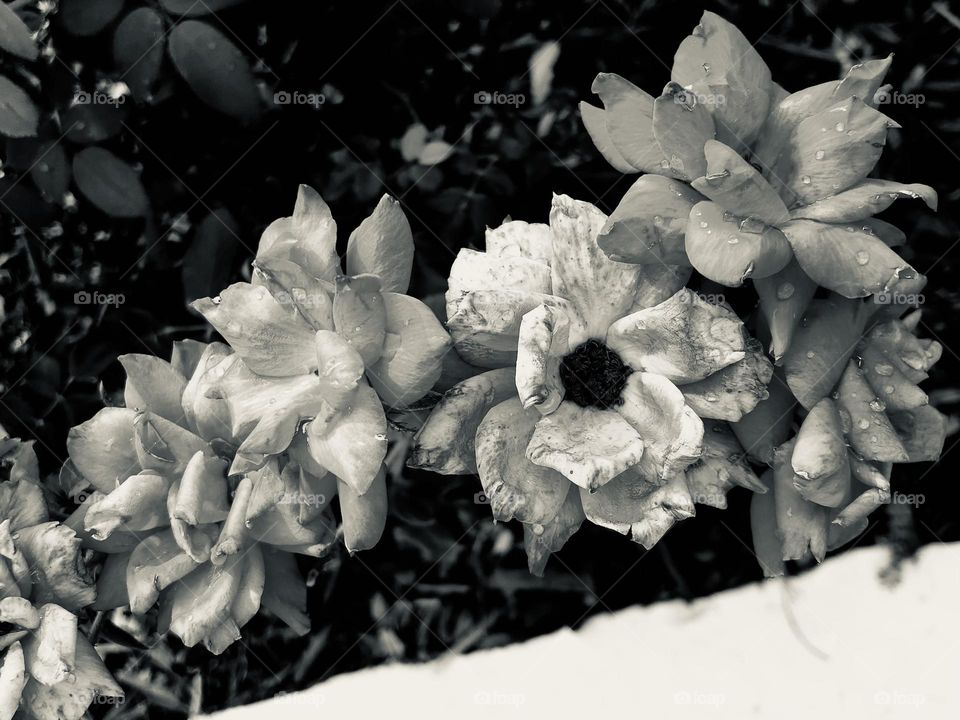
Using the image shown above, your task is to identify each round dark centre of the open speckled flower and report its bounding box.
[560,340,633,409]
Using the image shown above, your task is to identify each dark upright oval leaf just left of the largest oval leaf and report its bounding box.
[113,3,166,99]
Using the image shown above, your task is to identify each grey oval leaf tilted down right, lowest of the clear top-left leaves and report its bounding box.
[73,147,150,218]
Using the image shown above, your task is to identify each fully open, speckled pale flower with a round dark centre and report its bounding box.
[410,196,773,572]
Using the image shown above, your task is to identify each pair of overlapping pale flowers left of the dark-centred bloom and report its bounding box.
[66,187,450,653]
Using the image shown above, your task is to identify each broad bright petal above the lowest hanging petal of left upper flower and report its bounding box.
[306,385,387,494]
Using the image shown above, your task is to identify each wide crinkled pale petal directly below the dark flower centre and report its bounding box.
[524,402,643,491]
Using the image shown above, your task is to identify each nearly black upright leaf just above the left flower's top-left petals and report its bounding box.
[182,208,240,303]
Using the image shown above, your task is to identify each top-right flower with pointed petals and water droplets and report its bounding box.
[581,12,937,359]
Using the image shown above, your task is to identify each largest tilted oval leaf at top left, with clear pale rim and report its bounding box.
[169,20,260,120]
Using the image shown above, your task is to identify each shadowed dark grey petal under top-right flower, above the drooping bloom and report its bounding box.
[783,296,866,410]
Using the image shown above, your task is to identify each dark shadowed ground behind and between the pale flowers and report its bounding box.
[0,0,960,717]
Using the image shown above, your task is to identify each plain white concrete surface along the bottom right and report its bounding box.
[204,544,960,720]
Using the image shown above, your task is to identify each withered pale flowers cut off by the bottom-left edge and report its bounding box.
[0,428,123,720]
